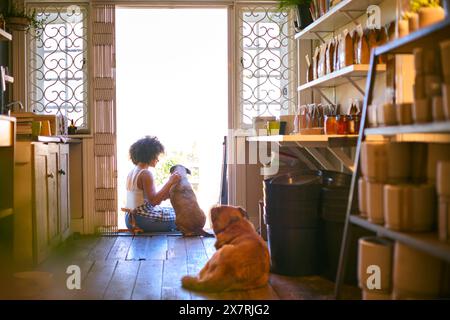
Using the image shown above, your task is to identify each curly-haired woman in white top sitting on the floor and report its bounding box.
[122,136,180,233]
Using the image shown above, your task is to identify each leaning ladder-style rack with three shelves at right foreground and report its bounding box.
[335,18,450,298]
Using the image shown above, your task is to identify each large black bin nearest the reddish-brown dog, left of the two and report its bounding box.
[264,171,322,276]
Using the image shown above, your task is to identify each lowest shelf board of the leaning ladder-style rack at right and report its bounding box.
[350,216,450,262]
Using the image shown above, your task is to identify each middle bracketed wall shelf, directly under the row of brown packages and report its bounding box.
[297,64,386,94]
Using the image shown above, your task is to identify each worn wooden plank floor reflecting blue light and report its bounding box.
[0,235,359,300]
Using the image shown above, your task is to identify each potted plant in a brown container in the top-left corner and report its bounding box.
[4,0,45,31]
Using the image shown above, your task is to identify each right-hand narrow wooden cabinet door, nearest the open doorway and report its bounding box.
[58,144,70,240]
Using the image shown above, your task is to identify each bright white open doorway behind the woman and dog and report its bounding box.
[116,7,228,229]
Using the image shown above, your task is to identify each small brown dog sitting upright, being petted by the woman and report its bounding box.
[169,164,213,237]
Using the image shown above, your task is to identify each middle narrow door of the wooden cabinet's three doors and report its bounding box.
[47,143,59,246]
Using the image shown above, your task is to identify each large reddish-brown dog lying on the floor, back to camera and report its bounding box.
[182,206,270,292]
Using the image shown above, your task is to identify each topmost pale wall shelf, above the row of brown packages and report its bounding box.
[295,0,383,40]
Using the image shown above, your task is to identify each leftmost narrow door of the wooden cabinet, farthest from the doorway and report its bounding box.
[33,143,49,263]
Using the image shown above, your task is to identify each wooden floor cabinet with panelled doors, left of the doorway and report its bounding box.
[14,142,70,265]
